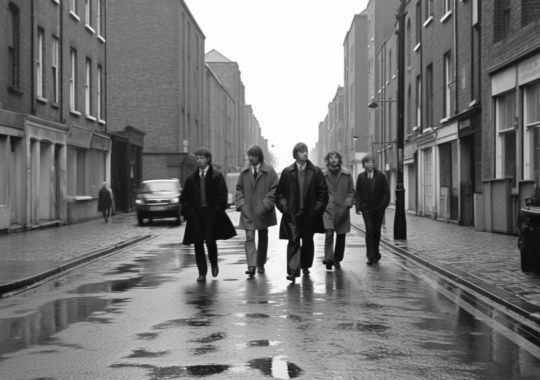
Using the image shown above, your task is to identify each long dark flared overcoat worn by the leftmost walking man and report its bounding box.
[180,165,236,245]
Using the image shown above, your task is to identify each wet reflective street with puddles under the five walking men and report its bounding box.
[0,214,540,379]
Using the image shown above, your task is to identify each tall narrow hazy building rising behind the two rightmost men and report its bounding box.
[343,11,369,177]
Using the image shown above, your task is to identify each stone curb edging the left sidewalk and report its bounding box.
[0,234,154,299]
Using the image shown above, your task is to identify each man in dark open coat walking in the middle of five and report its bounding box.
[276,143,328,283]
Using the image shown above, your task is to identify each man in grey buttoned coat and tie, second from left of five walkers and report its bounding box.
[236,145,278,278]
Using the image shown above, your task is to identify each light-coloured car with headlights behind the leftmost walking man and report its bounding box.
[135,179,182,225]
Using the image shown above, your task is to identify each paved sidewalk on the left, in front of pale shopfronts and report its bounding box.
[0,214,149,294]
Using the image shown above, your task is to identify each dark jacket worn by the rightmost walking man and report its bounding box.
[355,169,390,212]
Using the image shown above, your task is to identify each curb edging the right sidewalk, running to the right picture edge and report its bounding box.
[351,224,540,329]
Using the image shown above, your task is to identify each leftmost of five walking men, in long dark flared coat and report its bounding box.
[180,148,236,282]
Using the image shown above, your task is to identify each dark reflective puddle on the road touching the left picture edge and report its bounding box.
[0,297,126,355]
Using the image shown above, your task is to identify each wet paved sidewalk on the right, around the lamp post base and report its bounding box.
[352,209,540,306]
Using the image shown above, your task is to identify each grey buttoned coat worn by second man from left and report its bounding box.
[236,164,278,230]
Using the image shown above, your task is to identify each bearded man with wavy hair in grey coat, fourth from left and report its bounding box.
[323,151,355,270]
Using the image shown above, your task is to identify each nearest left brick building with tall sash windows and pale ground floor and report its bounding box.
[0,0,110,229]
